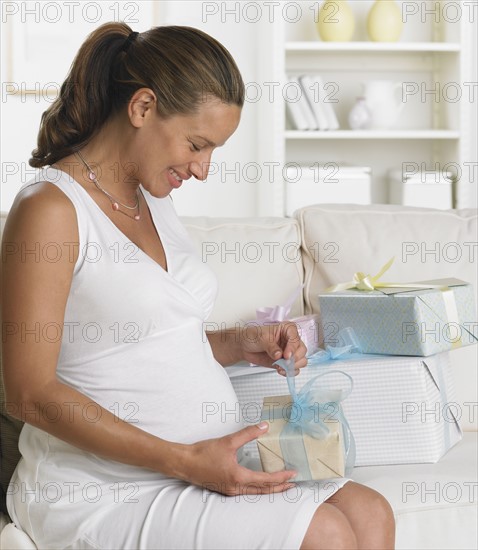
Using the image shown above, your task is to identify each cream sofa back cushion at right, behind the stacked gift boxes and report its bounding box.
[294,204,478,430]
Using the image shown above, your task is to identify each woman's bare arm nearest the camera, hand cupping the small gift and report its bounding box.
[0,183,293,494]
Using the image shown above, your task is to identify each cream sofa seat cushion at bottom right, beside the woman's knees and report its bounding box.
[350,433,478,550]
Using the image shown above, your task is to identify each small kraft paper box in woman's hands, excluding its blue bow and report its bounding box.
[257,395,345,481]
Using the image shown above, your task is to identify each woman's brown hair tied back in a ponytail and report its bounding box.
[29,23,245,168]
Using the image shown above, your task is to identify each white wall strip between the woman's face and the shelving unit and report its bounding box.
[159,0,260,217]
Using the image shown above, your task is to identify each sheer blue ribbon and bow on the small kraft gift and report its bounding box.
[262,358,355,481]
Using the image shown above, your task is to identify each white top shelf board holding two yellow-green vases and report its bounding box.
[285,41,461,53]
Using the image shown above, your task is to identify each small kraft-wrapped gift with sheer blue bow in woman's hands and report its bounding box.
[257,358,355,481]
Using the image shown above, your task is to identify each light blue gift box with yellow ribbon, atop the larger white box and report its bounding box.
[319,279,478,357]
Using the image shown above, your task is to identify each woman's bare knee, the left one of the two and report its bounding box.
[300,504,358,550]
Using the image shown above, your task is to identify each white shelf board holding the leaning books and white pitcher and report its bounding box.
[285,130,460,139]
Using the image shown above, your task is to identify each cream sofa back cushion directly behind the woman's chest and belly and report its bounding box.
[181,217,303,330]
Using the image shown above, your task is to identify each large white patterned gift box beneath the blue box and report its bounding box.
[226,352,462,466]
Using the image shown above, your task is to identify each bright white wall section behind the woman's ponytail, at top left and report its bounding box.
[0,0,159,210]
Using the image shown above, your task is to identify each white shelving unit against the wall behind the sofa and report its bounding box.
[257,0,478,215]
